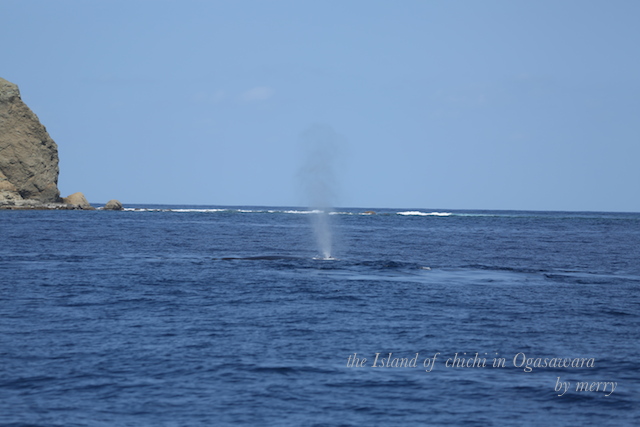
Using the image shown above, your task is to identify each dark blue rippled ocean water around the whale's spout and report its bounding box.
[0,206,640,426]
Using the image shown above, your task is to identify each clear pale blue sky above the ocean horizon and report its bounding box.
[0,0,640,212]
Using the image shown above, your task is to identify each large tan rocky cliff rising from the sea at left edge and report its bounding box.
[0,78,61,205]
